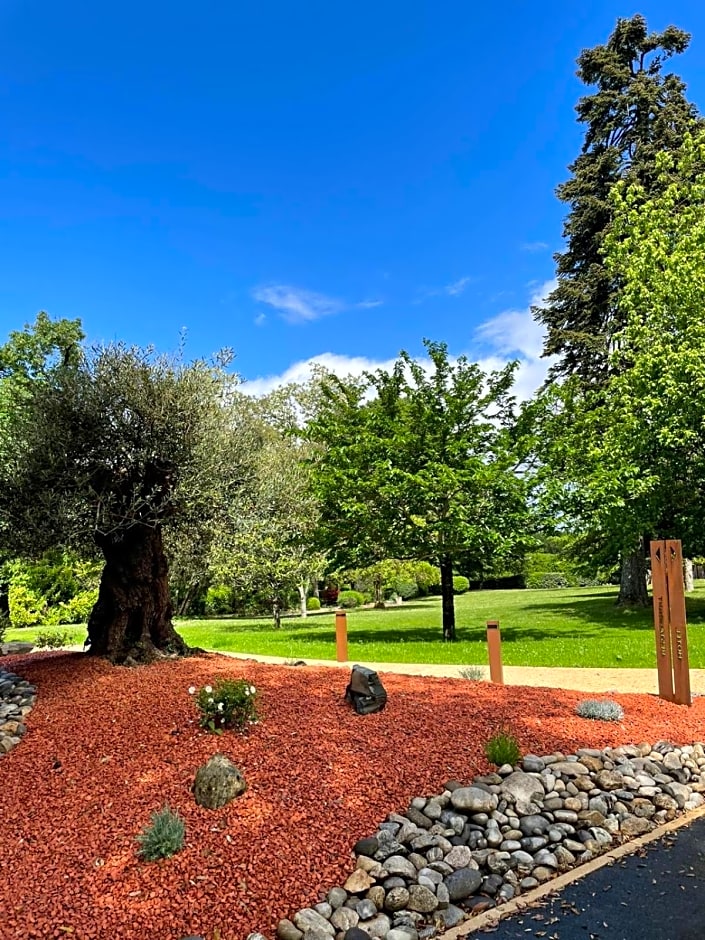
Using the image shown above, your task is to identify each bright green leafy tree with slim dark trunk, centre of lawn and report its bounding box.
[308,342,527,640]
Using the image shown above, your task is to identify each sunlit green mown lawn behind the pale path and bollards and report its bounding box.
[6,582,705,669]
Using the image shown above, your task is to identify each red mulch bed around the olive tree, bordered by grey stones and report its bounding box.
[0,653,705,940]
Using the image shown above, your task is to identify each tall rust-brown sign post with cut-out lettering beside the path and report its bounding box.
[651,539,691,705]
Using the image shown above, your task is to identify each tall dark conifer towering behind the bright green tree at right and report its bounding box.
[534,14,700,605]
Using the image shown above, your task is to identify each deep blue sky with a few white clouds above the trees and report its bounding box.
[0,0,705,390]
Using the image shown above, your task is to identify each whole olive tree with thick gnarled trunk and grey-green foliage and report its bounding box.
[0,328,252,662]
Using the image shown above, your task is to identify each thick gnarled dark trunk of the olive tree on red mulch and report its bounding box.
[88,525,188,665]
